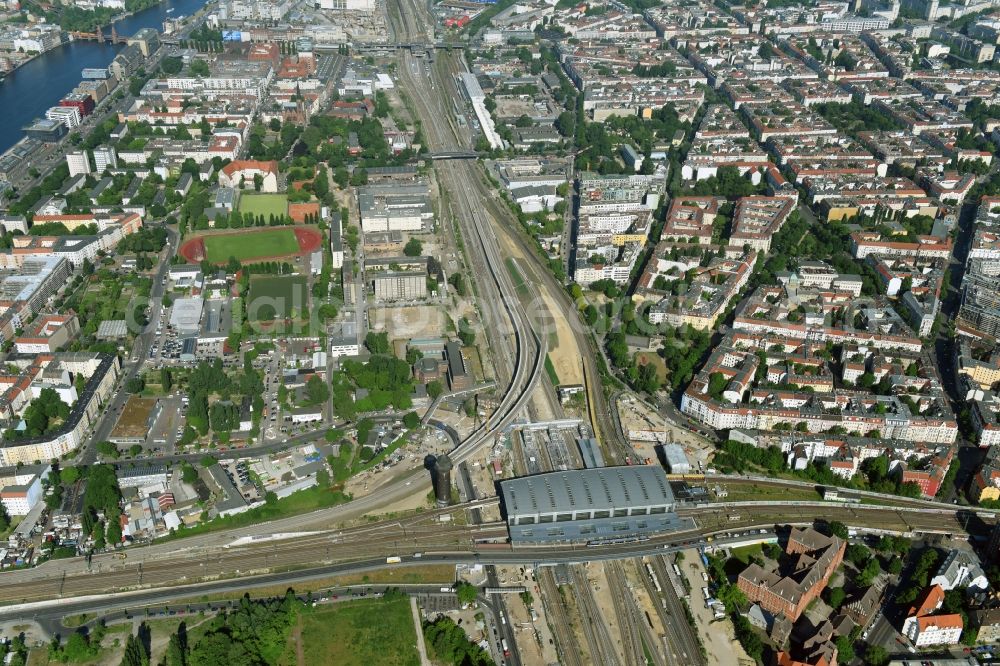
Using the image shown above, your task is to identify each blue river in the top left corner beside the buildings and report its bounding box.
[0,0,205,153]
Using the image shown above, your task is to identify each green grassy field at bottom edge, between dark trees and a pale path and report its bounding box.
[279,598,420,666]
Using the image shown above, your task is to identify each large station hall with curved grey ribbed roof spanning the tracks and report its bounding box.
[500,465,689,543]
